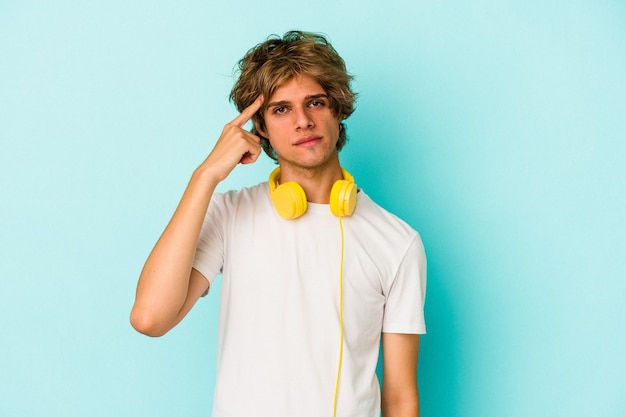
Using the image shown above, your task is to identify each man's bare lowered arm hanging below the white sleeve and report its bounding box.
[382,333,420,417]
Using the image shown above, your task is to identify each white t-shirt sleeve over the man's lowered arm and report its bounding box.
[383,234,426,334]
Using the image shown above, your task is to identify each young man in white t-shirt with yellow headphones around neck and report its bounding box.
[131,32,426,417]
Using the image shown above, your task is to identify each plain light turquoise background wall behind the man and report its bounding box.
[0,0,626,417]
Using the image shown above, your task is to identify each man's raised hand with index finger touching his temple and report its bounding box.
[199,96,263,182]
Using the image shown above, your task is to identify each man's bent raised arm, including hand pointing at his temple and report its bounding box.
[130,97,263,336]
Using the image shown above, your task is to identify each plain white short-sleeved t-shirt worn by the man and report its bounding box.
[194,183,426,417]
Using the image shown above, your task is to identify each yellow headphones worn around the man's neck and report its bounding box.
[268,168,357,220]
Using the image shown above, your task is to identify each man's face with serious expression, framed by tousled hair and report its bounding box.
[262,75,339,169]
